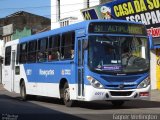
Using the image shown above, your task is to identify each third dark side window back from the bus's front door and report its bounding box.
[37,38,48,62]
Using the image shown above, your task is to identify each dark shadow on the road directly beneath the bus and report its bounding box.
[10,96,160,110]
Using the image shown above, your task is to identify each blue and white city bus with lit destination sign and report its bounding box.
[3,20,150,106]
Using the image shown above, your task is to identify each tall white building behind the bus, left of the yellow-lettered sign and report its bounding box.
[51,0,100,29]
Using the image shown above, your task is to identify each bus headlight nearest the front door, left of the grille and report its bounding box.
[87,76,104,89]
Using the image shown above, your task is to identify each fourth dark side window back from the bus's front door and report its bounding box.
[27,40,37,63]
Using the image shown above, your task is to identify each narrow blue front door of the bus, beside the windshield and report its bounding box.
[77,37,85,98]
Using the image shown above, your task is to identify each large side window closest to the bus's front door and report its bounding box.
[61,32,75,59]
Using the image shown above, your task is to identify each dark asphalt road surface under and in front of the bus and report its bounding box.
[0,86,160,120]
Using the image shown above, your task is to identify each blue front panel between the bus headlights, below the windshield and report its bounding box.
[85,70,149,90]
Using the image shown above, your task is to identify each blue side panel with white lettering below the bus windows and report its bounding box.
[24,61,76,84]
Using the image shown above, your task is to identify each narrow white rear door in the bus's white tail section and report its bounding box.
[11,50,15,91]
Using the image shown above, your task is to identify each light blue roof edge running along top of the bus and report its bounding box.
[20,19,146,43]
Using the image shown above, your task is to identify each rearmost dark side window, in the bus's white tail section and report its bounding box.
[5,46,11,66]
